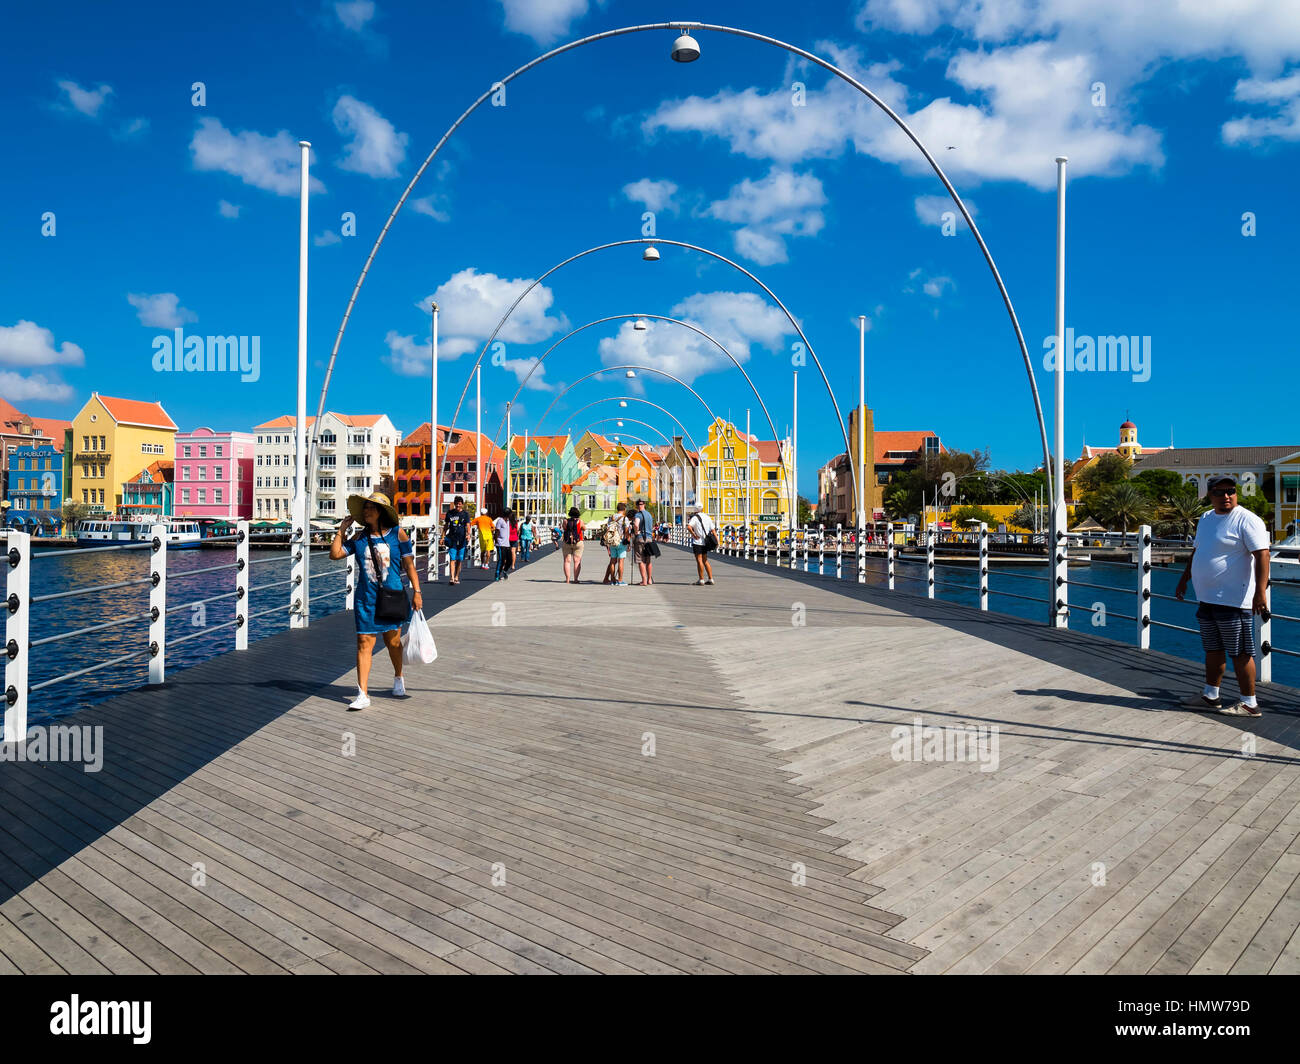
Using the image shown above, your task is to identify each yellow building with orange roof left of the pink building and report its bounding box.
[65,392,177,514]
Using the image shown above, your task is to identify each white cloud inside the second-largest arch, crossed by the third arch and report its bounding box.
[598,291,794,384]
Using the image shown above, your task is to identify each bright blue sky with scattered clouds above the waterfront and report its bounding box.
[0,0,1300,494]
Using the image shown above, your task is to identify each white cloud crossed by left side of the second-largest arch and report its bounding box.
[416,267,568,362]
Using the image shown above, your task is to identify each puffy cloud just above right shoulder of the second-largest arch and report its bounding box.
[706,168,827,265]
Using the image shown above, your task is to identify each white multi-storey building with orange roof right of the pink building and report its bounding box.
[252,411,402,520]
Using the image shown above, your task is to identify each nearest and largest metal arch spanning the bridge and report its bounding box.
[314,22,1052,520]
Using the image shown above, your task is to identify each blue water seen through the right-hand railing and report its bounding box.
[759,552,1300,687]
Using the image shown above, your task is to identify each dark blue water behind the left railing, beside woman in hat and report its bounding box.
[19,545,347,725]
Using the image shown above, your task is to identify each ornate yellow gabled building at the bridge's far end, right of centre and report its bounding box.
[699,418,793,525]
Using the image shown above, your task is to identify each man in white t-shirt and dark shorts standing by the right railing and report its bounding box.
[1174,476,1269,717]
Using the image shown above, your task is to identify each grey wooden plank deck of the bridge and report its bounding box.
[0,544,1300,973]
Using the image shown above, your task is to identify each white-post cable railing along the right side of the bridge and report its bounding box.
[671,522,1300,683]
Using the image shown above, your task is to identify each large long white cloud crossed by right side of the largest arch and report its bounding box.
[642,42,1164,190]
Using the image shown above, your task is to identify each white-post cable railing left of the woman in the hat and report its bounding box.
[0,520,356,743]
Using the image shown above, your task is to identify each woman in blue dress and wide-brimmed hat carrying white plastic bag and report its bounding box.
[329,492,424,709]
